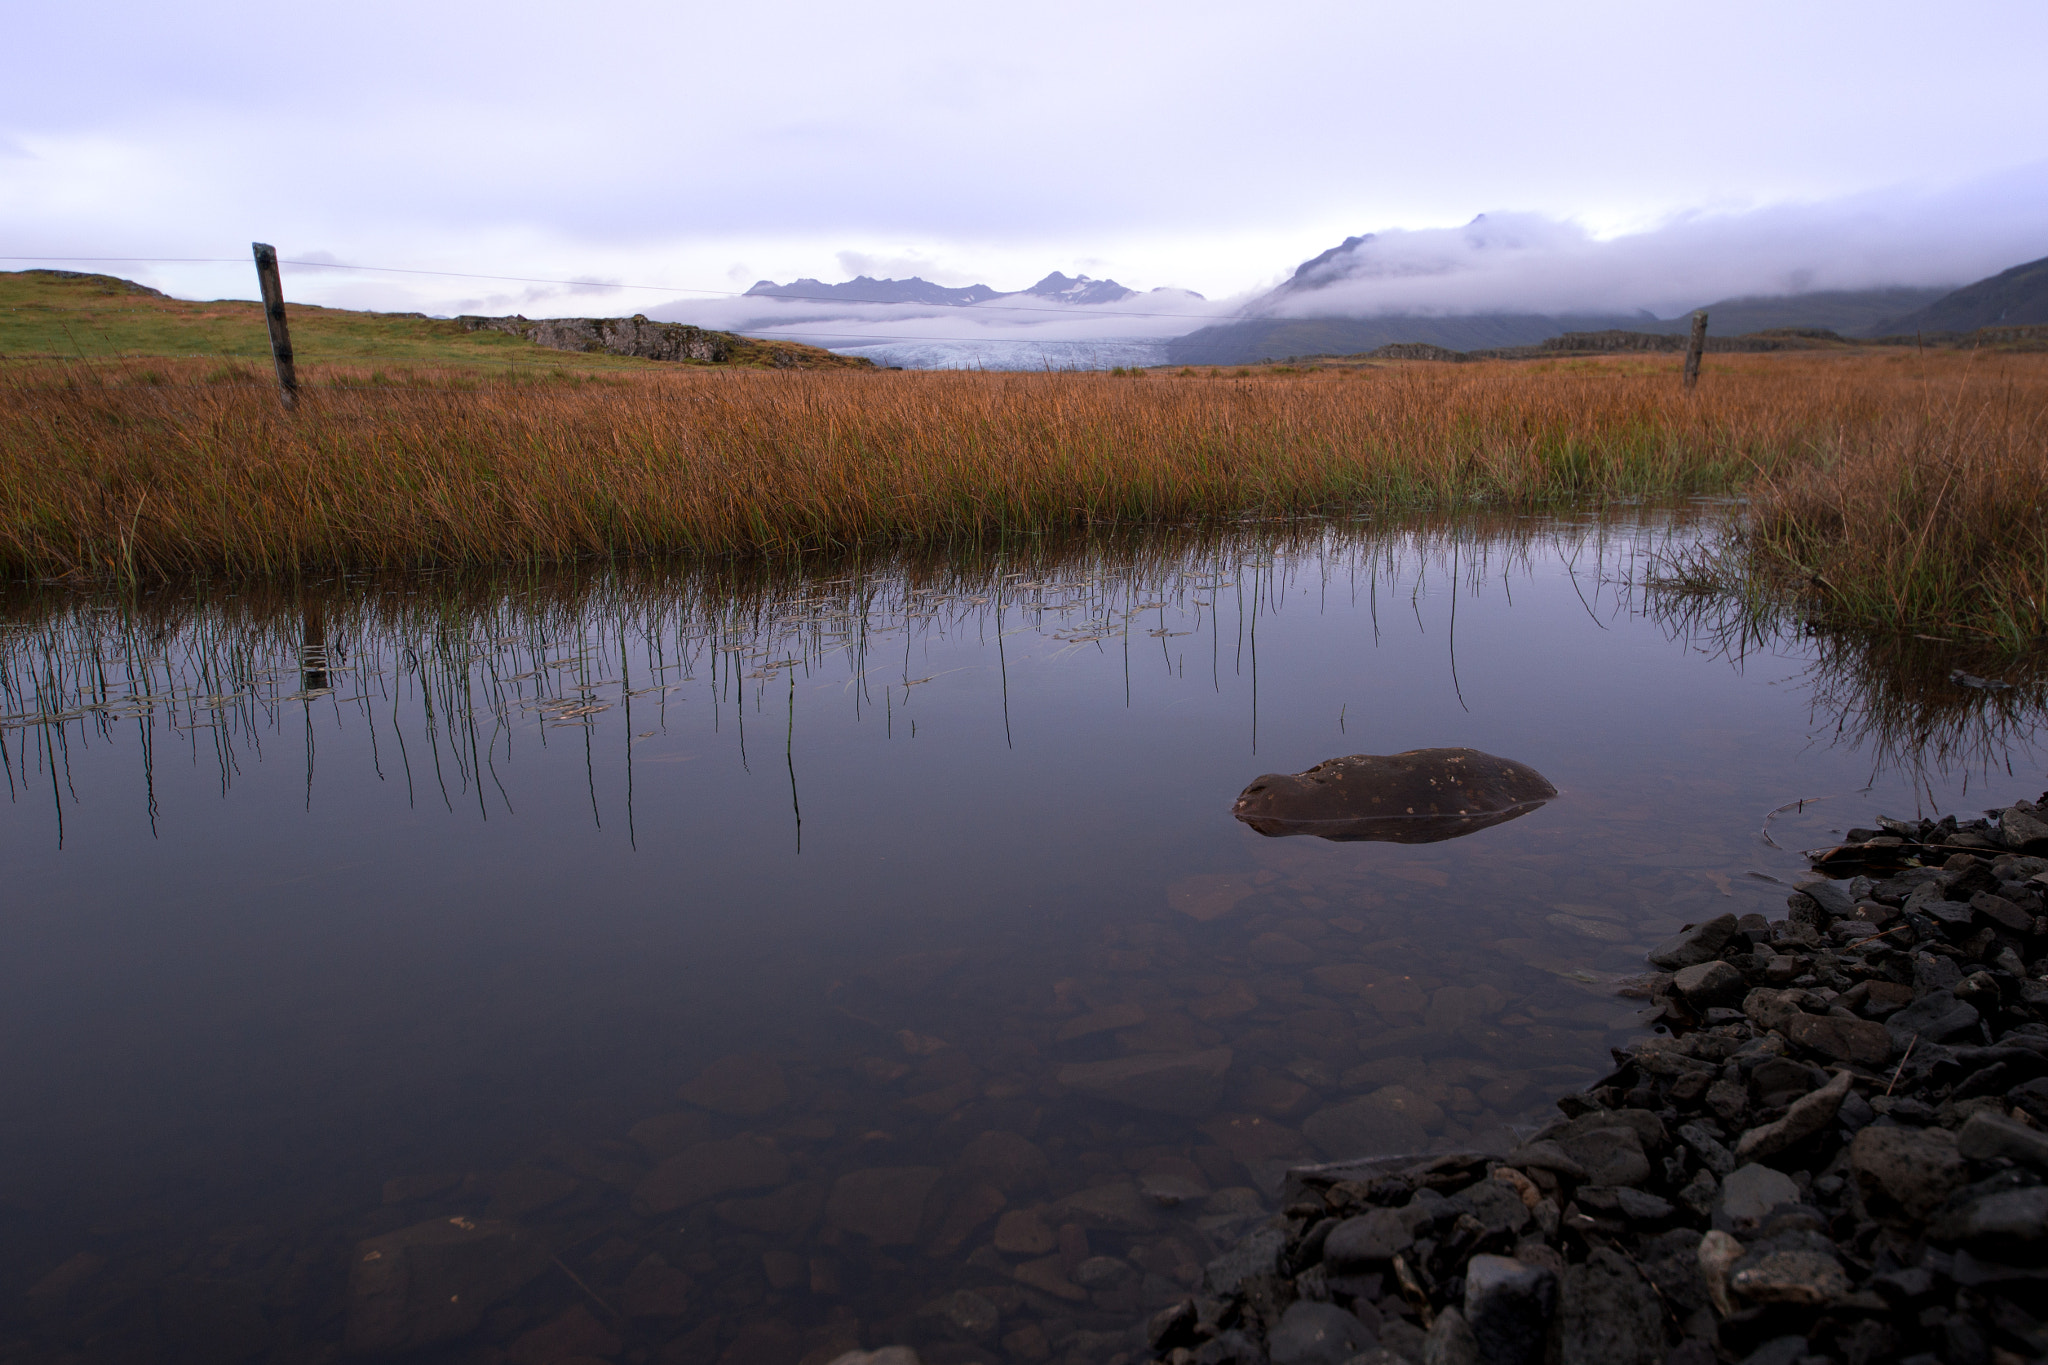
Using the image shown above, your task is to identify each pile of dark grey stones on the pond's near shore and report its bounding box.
[1147,796,2048,1365]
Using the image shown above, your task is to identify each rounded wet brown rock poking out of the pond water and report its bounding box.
[1231,749,1556,843]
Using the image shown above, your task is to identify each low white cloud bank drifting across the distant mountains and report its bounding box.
[649,162,2048,368]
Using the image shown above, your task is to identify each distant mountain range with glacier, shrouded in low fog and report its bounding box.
[638,162,2048,366]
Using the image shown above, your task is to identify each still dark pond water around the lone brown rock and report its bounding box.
[0,516,2040,1365]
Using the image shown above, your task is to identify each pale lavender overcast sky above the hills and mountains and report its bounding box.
[0,0,2048,325]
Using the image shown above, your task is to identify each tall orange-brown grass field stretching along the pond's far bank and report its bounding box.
[0,350,2048,645]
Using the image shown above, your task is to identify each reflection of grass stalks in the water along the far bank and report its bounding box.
[0,512,1654,817]
